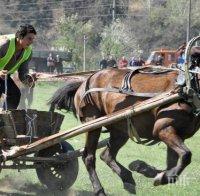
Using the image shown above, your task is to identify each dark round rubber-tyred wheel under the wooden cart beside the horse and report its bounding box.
[35,142,79,190]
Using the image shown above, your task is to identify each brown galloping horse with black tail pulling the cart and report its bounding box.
[50,53,200,195]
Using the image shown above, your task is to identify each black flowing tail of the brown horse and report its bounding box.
[48,81,83,116]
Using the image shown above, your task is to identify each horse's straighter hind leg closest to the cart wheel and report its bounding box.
[82,129,105,196]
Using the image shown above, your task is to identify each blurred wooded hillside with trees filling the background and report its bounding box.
[0,0,200,69]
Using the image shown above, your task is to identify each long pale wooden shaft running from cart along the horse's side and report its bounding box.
[6,92,181,160]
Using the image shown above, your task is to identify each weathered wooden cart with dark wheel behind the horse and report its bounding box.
[0,110,78,190]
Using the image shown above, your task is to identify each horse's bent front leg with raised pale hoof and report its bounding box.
[154,126,192,186]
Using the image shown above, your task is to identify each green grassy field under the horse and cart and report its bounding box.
[0,80,200,196]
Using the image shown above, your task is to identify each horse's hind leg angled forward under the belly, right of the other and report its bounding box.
[100,130,135,193]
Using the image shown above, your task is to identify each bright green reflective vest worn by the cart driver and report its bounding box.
[0,34,32,74]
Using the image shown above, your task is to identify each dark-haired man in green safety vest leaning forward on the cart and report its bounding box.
[0,25,36,109]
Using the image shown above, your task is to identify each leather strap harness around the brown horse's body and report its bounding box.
[80,67,200,145]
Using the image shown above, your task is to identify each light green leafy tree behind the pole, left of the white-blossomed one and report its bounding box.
[53,14,93,70]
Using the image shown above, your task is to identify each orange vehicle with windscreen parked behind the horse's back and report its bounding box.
[145,49,178,67]
